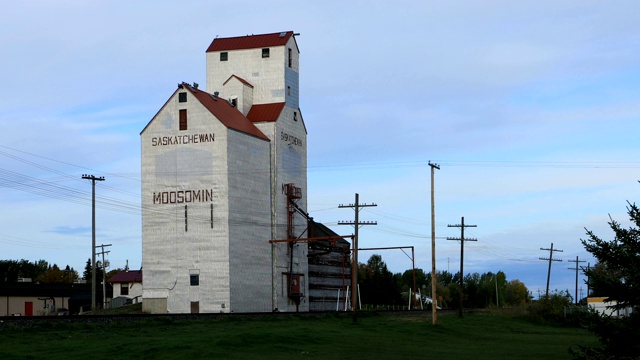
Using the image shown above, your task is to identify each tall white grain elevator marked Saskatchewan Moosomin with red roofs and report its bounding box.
[141,32,309,313]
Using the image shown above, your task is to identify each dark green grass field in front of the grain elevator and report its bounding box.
[0,313,597,360]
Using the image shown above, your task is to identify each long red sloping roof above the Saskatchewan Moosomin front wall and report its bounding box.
[182,83,269,141]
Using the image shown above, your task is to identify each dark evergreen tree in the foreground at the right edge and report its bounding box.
[572,202,640,359]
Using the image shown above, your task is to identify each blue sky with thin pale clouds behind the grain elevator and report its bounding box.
[0,0,640,295]
